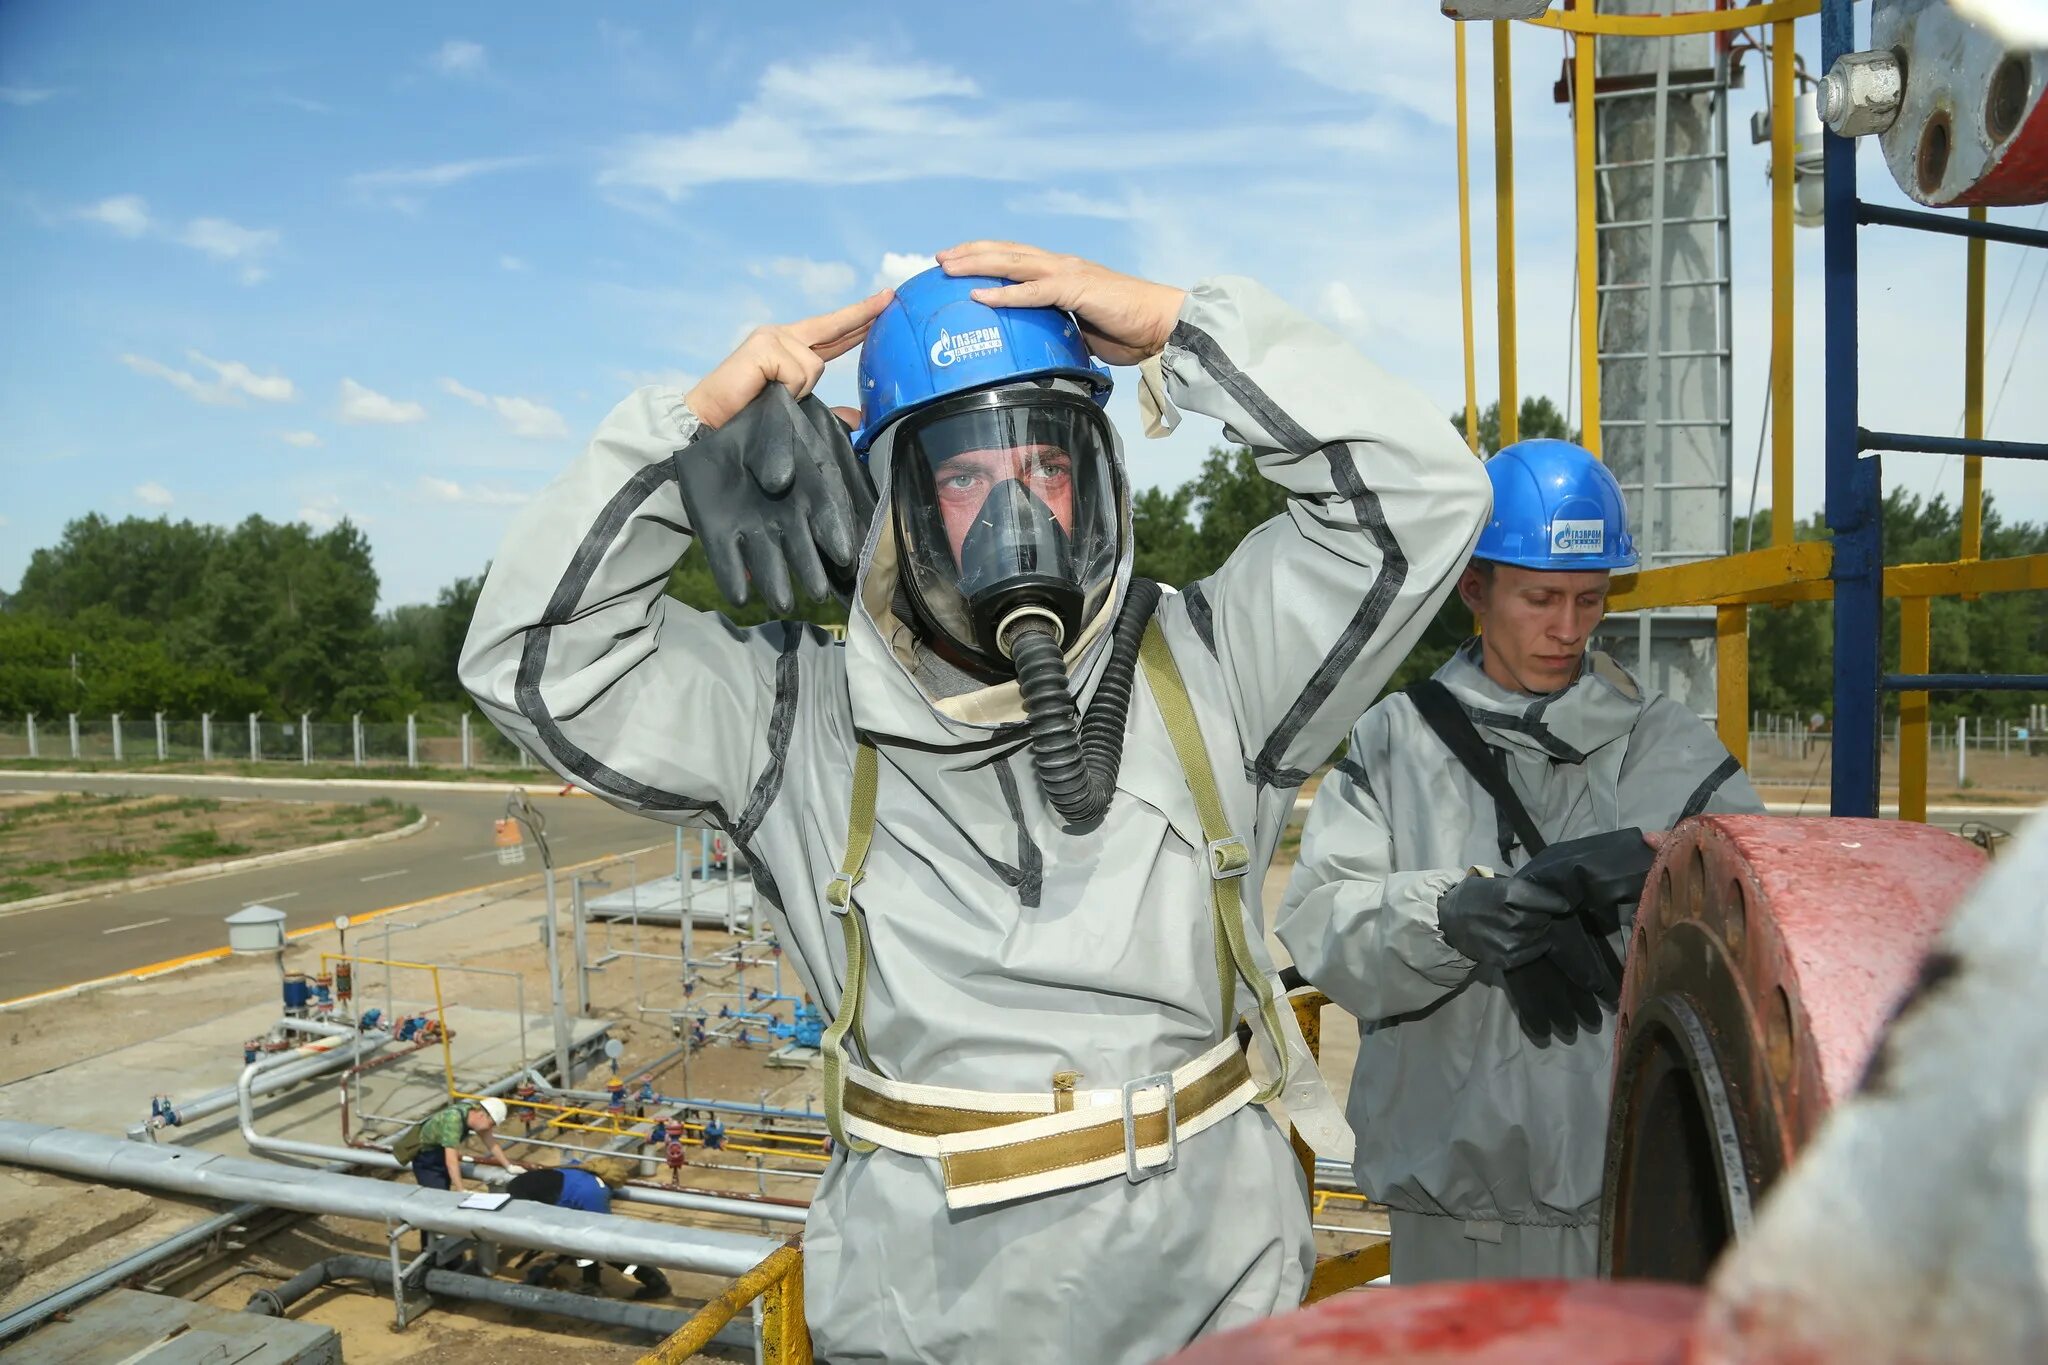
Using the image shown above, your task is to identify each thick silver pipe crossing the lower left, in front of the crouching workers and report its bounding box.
[0,1119,782,1277]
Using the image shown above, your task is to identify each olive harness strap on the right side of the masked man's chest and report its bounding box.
[1139,616,1288,1105]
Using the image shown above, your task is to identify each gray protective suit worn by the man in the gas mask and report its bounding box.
[463,280,1489,1365]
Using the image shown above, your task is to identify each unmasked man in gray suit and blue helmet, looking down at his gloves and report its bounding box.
[1276,440,1763,1283]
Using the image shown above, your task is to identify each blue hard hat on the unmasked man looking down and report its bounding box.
[1473,440,1636,569]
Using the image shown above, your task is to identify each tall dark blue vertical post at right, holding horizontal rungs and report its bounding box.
[1835,0,1884,817]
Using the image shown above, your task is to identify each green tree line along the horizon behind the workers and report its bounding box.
[12,397,2048,720]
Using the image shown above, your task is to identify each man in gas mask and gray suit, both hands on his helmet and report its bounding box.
[463,241,1487,1365]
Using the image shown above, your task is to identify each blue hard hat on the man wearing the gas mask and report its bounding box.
[854,266,1110,458]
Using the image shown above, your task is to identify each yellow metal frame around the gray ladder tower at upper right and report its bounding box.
[1454,0,2023,821]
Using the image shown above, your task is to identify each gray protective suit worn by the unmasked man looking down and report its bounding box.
[1276,641,1763,1281]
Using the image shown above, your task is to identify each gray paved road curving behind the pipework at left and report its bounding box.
[0,772,670,1001]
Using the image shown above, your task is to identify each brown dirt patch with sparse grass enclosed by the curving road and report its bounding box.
[0,794,420,902]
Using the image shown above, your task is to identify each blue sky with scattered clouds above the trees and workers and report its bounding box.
[0,0,2048,604]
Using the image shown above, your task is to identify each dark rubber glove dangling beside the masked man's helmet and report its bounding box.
[676,385,874,612]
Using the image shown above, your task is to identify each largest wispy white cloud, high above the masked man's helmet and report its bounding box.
[598,48,1286,207]
